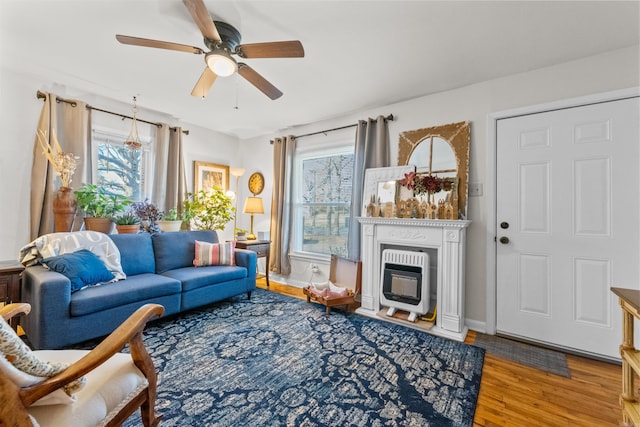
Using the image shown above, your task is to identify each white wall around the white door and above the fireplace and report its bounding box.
[242,46,640,330]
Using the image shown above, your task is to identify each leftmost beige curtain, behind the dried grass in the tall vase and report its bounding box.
[30,93,91,240]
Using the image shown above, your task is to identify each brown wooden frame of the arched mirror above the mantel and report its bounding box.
[398,121,471,219]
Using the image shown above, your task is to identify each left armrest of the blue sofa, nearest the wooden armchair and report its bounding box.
[20,265,71,349]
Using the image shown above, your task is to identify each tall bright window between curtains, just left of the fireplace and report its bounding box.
[293,144,353,256]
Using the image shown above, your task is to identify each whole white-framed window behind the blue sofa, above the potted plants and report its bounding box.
[92,128,151,201]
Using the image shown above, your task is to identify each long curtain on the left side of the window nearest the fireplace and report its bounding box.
[269,135,295,276]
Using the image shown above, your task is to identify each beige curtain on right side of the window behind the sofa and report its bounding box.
[150,123,187,212]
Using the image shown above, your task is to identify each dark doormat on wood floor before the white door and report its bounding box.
[473,334,571,378]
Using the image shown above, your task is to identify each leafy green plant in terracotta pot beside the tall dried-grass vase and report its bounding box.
[74,184,131,234]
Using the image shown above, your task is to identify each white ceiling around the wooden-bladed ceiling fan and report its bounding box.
[0,0,640,139]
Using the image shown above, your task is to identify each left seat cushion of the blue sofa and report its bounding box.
[69,273,181,316]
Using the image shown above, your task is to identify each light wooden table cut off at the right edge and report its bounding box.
[611,288,640,427]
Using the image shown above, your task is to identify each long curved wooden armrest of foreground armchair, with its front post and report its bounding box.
[20,304,164,406]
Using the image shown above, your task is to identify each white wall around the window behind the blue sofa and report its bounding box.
[0,68,244,260]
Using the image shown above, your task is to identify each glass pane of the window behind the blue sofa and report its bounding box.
[98,143,143,200]
